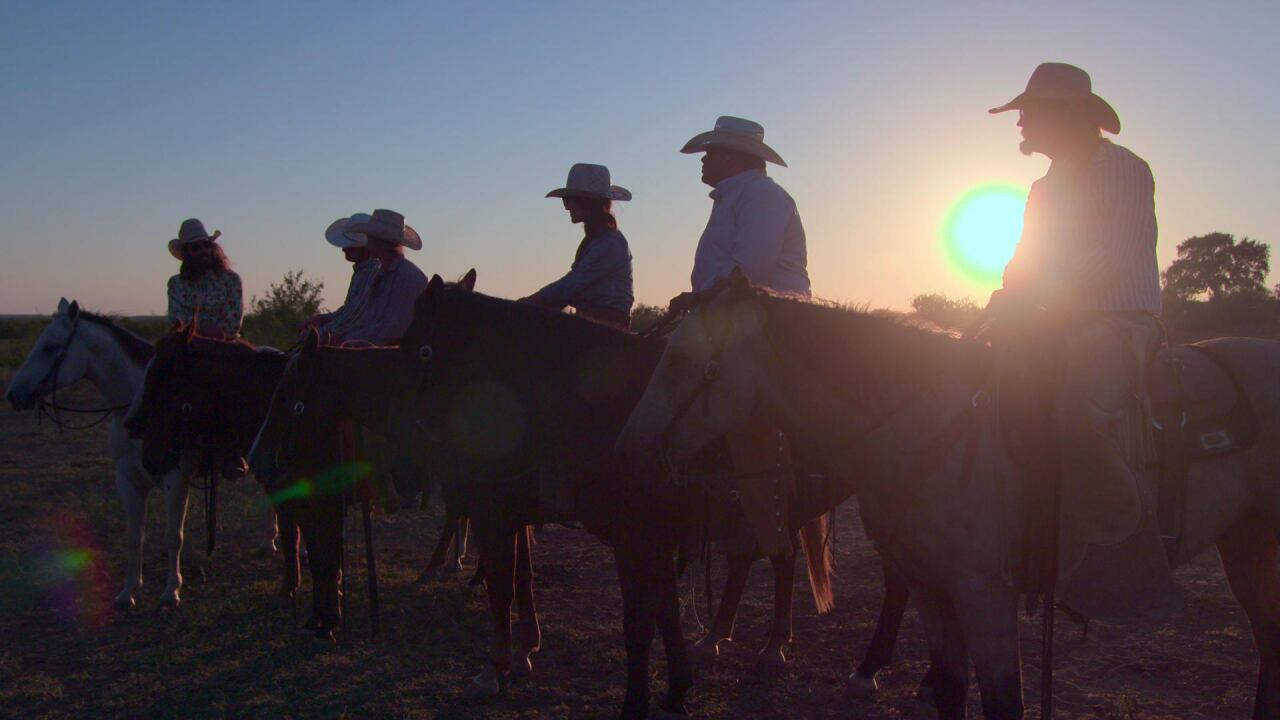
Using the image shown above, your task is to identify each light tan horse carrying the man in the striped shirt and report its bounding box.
[618,271,1280,719]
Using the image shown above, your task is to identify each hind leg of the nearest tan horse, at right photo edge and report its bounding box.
[1217,518,1280,720]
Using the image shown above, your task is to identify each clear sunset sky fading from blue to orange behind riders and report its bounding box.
[0,1,1280,314]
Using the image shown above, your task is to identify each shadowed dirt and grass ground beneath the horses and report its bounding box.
[0,386,1256,720]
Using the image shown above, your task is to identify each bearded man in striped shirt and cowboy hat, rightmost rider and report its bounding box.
[988,63,1169,618]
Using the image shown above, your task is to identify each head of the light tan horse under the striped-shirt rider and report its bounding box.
[617,269,768,477]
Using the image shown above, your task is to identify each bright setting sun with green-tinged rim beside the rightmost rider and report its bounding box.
[942,183,1027,286]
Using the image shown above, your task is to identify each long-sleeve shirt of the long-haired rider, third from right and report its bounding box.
[529,231,635,316]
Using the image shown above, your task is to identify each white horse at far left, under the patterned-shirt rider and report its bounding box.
[5,297,188,610]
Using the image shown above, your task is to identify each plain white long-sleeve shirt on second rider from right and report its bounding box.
[690,170,809,295]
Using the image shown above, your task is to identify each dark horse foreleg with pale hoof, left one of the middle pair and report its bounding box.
[463,523,516,700]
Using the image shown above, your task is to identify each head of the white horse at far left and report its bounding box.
[5,297,92,410]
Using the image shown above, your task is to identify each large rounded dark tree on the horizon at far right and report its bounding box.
[1165,232,1271,302]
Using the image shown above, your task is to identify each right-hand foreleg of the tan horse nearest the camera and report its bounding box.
[957,582,1023,720]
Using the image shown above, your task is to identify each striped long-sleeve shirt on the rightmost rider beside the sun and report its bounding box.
[1004,141,1161,315]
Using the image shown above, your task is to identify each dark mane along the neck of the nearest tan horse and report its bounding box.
[751,288,986,404]
